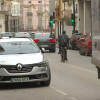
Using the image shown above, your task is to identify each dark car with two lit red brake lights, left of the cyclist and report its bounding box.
[34,33,56,52]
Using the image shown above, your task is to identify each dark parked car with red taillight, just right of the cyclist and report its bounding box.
[69,33,82,50]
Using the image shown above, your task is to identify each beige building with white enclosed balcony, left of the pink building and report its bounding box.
[0,0,23,32]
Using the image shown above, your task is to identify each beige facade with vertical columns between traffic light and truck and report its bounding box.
[78,0,92,33]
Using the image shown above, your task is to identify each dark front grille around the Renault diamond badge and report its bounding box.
[1,64,34,73]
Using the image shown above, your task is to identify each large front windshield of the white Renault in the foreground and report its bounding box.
[0,41,40,55]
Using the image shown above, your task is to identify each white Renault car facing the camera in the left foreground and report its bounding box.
[0,38,51,86]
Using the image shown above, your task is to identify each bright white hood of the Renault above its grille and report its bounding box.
[0,53,43,65]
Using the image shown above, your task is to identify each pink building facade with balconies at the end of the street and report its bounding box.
[23,0,49,31]
